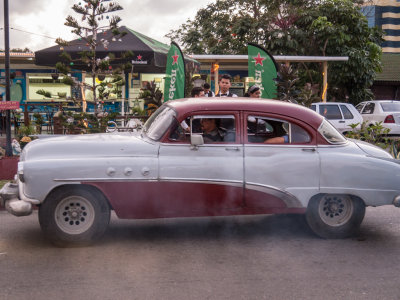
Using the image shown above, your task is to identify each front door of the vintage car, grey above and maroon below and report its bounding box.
[159,112,243,216]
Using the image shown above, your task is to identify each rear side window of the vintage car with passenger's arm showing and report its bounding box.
[247,115,311,144]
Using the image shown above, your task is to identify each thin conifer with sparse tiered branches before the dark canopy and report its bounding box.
[56,0,132,113]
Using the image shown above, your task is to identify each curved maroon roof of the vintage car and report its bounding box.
[166,97,323,128]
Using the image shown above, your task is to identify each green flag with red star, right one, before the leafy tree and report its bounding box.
[248,43,278,99]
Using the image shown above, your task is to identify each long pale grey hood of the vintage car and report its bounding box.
[20,133,158,161]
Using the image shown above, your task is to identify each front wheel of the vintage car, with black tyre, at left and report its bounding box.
[39,187,110,247]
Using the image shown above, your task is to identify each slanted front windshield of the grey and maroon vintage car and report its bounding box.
[142,105,176,141]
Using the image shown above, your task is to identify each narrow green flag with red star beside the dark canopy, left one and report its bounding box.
[164,42,185,101]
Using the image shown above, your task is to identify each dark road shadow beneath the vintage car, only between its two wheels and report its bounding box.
[103,215,315,242]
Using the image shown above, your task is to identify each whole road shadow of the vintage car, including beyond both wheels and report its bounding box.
[0,209,399,248]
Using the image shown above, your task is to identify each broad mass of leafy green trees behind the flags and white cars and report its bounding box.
[167,0,383,103]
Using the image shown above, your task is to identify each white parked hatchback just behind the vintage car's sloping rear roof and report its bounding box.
[311,102,363,133]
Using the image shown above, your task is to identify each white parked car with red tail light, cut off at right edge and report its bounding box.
[356,100,400,135]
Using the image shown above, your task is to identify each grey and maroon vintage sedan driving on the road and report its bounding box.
[0,98,400,246]
